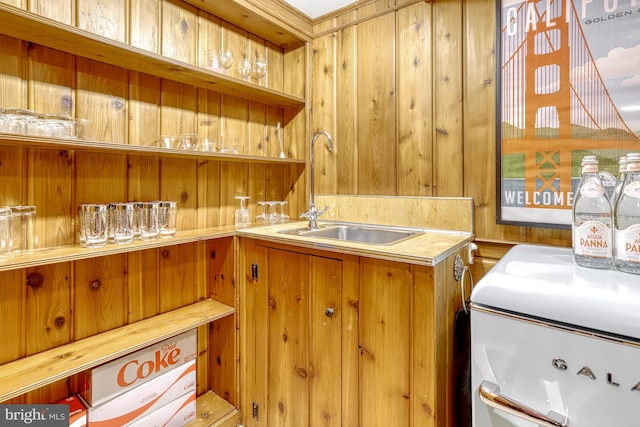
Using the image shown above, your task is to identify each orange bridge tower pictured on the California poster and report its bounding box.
[524,0,572,209]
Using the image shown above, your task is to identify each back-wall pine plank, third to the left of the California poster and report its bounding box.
[396,2,434,196]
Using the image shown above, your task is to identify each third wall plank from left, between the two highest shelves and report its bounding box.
[76,57,127,144]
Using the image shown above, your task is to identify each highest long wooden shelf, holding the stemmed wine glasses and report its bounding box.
[0,3,305,111]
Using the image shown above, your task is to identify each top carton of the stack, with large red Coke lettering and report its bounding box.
[80,329,198,406]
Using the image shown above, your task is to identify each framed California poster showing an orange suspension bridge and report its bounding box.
[497,0,640,228]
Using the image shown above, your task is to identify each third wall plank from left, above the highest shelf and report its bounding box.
[76,0,128,43]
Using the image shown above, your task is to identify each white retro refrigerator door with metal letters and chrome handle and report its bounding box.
[471,305,640,427]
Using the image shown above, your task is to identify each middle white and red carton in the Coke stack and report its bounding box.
[87,360,196,427]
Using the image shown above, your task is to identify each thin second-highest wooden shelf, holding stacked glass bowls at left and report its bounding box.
[0,133,305,165]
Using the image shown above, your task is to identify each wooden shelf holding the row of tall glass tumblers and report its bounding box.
[0,225,242,271]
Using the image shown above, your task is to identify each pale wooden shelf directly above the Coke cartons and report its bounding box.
[0,299,235,402]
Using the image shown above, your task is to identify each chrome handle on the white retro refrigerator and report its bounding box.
[478,381,569,427]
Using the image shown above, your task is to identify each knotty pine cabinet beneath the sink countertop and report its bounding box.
[239,238,461,427]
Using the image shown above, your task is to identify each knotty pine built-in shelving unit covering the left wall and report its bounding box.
[0,0,306,426]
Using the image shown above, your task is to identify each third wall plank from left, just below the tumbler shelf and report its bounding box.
[72,254,128,341]
